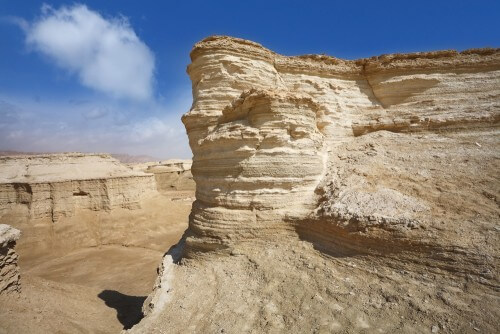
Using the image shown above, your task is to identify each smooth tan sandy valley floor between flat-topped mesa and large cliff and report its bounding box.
[0,192,193,333]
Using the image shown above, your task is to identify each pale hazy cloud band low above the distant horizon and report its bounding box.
[0,92,191,158]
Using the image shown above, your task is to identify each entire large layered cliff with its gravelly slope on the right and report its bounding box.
[134,36,500,333]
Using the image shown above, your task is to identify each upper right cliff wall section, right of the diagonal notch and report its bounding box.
[353,49,500,135]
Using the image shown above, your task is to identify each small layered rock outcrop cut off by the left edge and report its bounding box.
[0,224,21,295]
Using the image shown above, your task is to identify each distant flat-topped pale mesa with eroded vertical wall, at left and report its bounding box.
[0,153,156,221]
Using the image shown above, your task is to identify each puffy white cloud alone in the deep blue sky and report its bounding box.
[20,5,155,100]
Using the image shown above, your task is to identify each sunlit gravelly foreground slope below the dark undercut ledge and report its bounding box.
[132,239,500,333]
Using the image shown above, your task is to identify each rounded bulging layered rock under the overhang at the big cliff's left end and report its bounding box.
[189,90,326,247]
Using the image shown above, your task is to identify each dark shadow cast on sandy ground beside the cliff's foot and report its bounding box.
[97,290,146,329]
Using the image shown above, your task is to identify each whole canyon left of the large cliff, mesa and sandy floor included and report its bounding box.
[0,153,194,333]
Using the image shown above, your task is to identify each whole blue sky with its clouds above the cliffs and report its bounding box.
[0,0,500,158]
